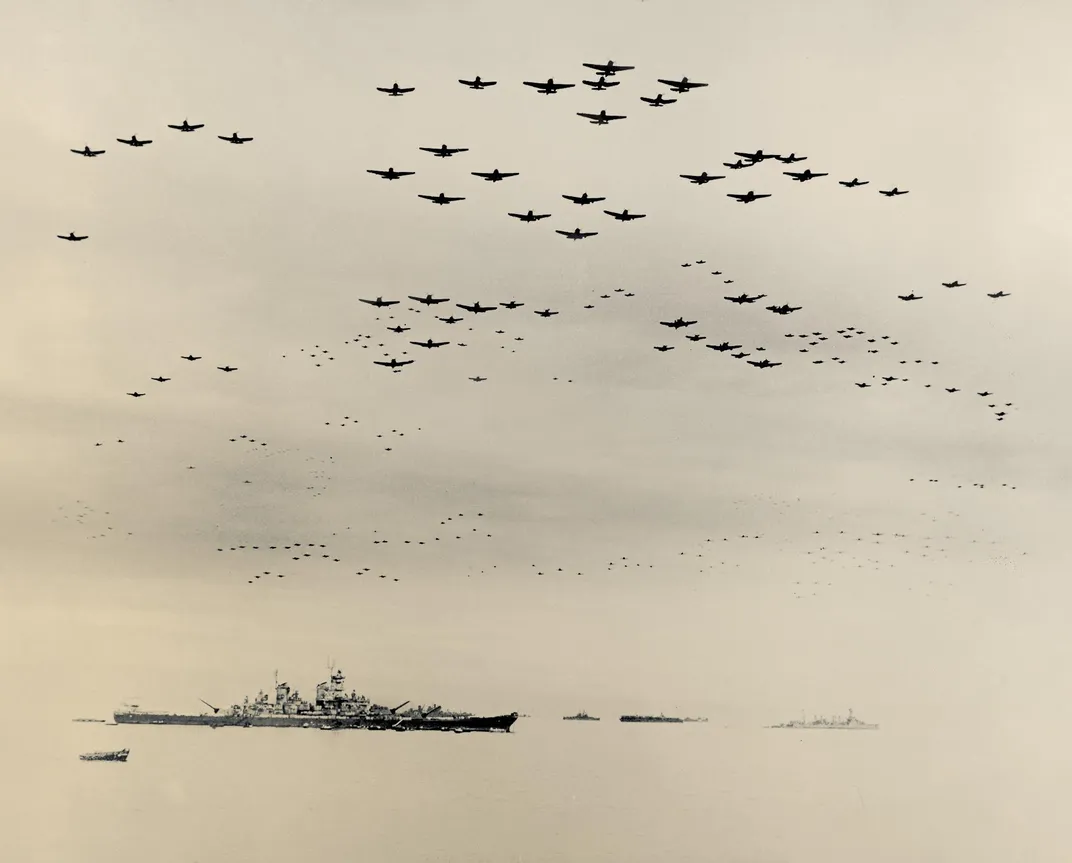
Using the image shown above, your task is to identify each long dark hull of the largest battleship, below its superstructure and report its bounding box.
[115,711,518,731]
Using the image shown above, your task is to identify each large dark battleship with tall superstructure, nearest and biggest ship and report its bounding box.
[114,669,518,733]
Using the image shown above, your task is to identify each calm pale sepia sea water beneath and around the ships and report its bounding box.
[6,718,1072,863]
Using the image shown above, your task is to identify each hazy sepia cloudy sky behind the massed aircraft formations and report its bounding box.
[0,0,1072,724]
